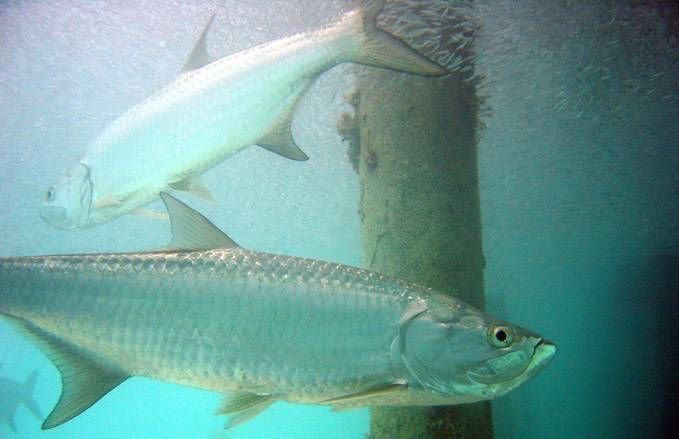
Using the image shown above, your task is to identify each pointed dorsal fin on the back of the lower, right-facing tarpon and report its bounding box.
[160,192,238,250]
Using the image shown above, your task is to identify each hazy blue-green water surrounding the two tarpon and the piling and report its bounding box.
[0,0,679,439]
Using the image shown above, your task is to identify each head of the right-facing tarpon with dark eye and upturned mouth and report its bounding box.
[392,295,556,405]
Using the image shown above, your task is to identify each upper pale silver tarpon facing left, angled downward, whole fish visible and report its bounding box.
[41,0,446,229]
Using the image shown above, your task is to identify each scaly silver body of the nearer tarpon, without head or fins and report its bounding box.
[0,249,414,402]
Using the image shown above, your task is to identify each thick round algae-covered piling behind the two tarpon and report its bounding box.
[348,69,492,439]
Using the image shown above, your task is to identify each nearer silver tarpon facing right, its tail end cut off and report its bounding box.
[0,194,556,428]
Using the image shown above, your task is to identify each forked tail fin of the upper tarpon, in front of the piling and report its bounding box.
[343,0,448,76]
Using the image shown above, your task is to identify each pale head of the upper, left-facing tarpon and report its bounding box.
[40,163,92,229]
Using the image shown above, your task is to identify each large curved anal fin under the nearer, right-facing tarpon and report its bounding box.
[0,315,128,430]
